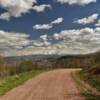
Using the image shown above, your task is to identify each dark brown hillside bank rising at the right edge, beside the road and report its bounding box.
[80,64,100,91]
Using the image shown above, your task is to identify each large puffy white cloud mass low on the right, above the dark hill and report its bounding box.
[53,27,100,54]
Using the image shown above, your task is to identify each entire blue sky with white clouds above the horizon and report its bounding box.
[0,0,100,56]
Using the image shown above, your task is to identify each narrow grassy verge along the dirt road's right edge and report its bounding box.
[73,70,100,100]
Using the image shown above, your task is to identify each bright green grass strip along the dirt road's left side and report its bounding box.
[0,70,44,95]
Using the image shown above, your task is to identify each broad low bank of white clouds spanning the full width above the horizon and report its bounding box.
[0,27,100,56]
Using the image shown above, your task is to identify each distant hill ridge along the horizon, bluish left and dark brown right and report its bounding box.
[4,51,100,68]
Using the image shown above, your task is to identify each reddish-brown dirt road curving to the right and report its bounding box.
[0,69,84,100]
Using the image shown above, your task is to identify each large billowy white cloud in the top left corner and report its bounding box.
[0,0,36,19]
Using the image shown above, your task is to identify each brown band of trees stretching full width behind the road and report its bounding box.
[0,52,100,77]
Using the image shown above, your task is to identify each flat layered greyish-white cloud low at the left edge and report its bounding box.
[0,30,30,49]
